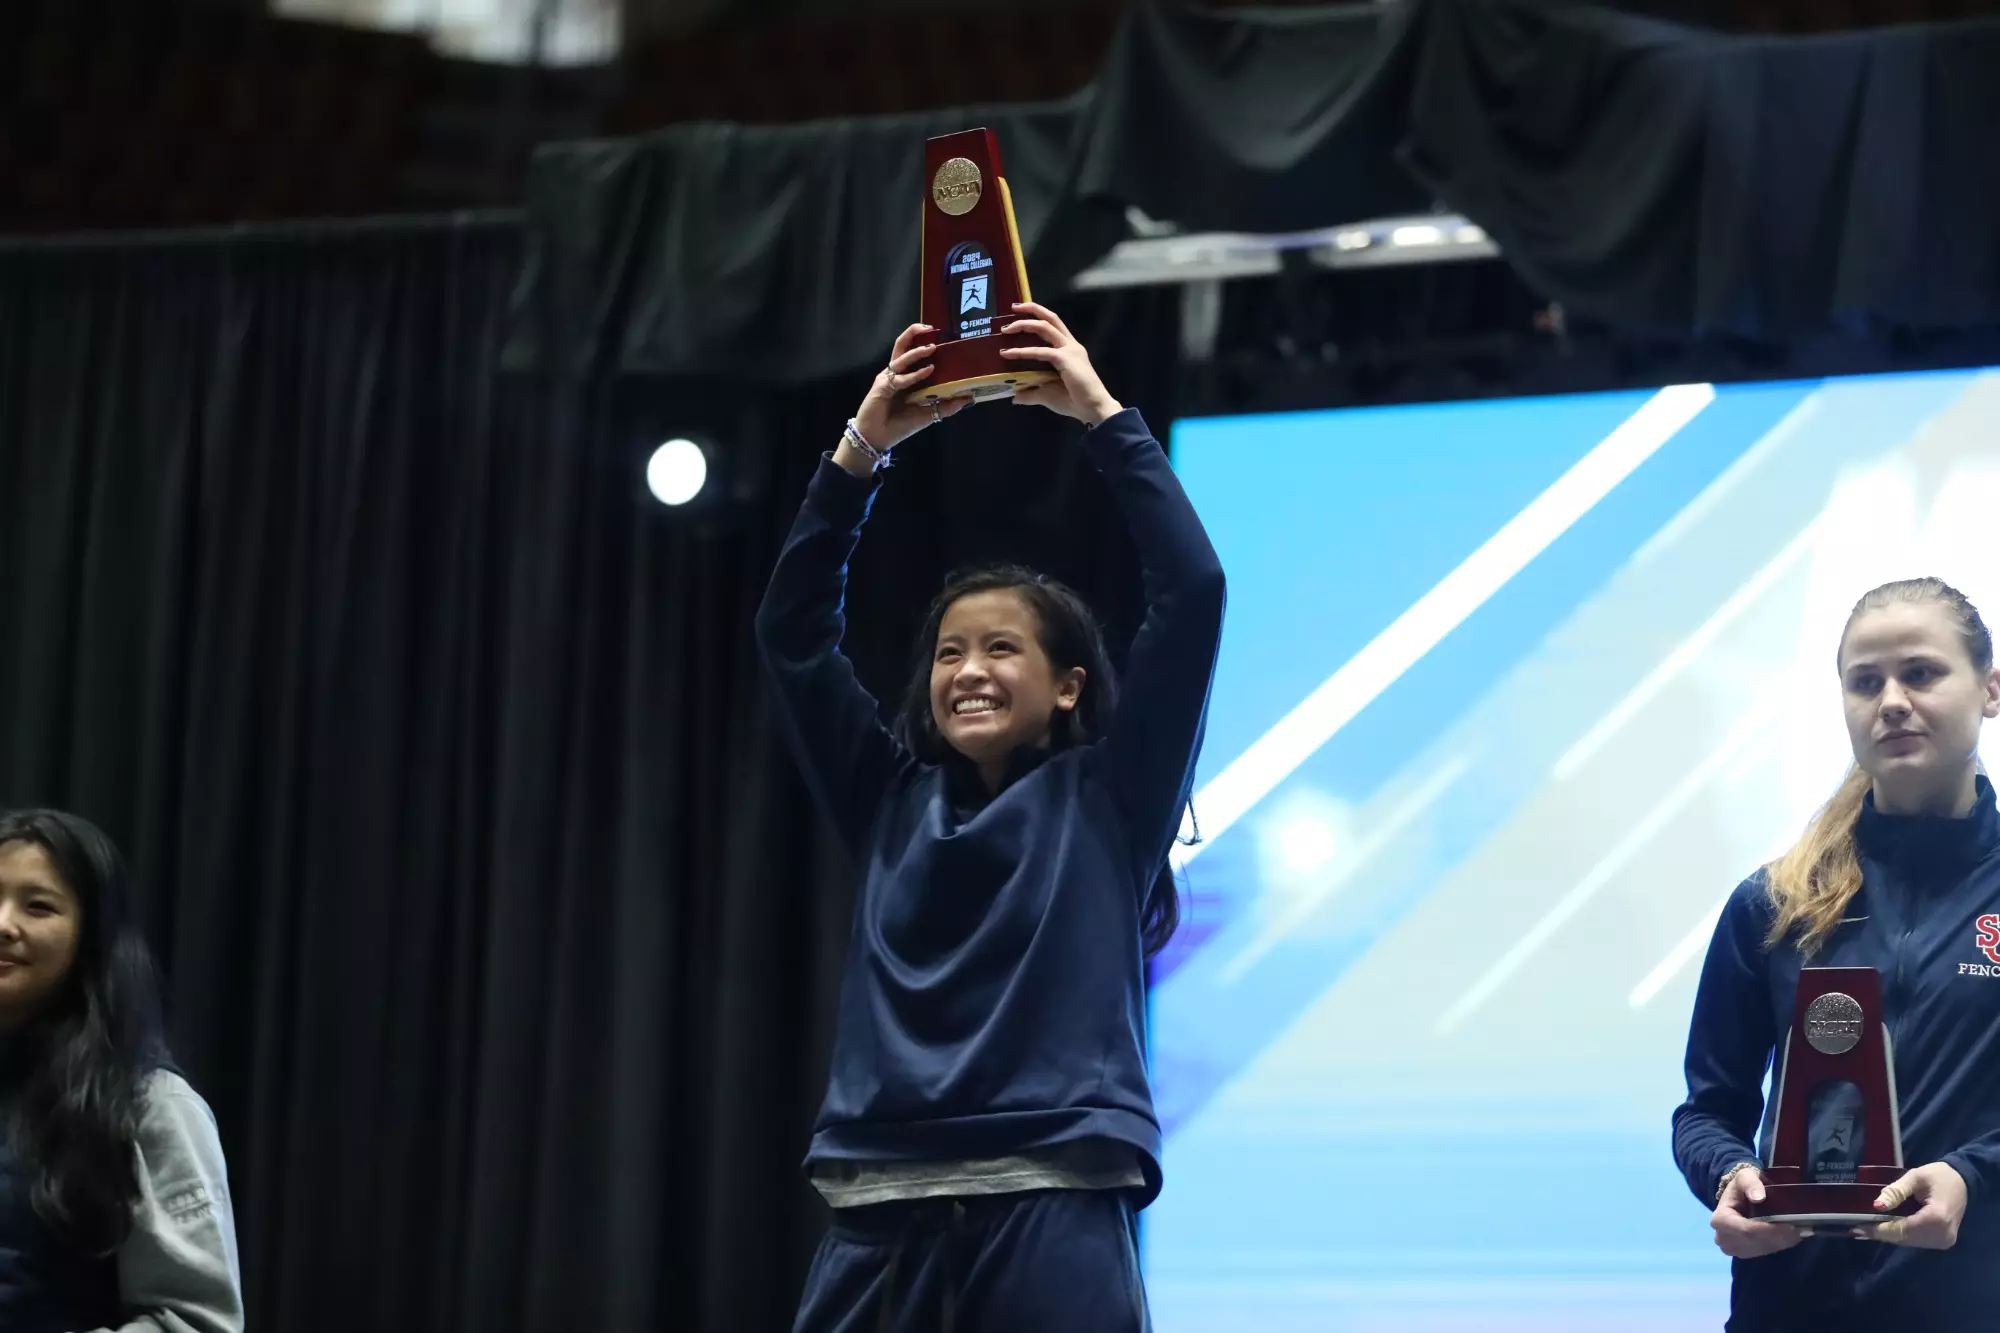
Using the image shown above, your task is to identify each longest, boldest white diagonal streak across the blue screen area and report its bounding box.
[1172,384,1716,867]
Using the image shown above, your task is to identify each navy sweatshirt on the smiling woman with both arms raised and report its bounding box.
[756,408,1222,1203]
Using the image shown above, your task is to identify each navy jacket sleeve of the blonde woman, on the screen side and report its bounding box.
[1674,871,1778,1209]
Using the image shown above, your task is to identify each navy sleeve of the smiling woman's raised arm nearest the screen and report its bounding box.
[1084,408,1224,881]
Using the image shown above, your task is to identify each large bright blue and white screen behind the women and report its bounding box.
[1146,370,2000,1333]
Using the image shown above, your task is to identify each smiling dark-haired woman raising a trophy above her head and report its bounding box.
[758,304,1222,1333]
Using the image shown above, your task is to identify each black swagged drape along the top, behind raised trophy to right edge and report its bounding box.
[510,0,2000,382]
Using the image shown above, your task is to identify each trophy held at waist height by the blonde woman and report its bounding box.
[1744,967,1922,1227]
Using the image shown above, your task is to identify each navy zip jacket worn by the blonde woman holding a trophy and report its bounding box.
[1674,777,2000,1333]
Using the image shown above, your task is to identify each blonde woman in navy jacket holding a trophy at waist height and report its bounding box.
[1674,578,2000,1333]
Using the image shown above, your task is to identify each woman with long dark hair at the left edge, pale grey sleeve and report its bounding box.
[0,811,244,1333]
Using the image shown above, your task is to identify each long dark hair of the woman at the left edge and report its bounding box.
[0,811,168,1255]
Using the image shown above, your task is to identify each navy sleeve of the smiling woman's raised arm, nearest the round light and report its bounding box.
[756,458,902,861]
